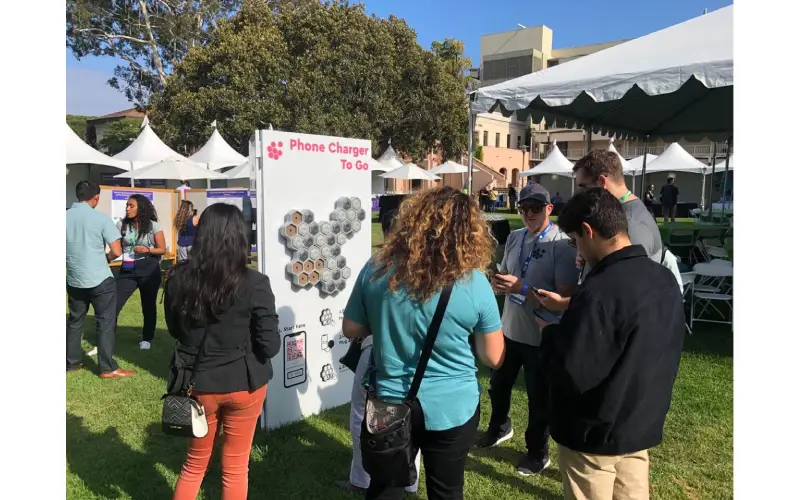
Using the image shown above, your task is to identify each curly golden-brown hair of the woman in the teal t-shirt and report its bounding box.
[372,187,497,302]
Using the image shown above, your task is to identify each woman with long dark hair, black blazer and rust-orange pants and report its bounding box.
[164,204,280,500]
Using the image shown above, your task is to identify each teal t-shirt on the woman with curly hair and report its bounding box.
[344,261,501,431]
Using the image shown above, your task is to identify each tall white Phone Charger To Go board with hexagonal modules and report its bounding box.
[254,130,372,429]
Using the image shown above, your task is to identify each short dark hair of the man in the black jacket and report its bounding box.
[558,188,628,240]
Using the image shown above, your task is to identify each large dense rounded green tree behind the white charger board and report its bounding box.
[150,0,467,159]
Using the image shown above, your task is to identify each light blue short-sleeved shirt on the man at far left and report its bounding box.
[67,202,121,288]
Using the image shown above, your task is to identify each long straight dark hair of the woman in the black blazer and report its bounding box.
[168,203,250,325]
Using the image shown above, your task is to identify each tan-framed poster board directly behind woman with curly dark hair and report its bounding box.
[96,186,177,259]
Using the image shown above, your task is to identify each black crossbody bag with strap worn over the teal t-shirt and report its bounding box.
[361,285,453,487]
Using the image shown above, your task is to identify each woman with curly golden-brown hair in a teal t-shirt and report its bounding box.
[342,187,505,500]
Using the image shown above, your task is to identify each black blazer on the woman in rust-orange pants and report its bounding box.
[164,269,281,393]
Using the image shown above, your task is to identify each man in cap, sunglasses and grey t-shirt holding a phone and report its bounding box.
[476,183,578,476]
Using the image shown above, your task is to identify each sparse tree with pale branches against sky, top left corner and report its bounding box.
[66,0,241,105]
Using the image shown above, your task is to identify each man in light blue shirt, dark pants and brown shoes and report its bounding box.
[66,181,136,378]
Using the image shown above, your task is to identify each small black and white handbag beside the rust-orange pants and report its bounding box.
[161,326,208,438]
